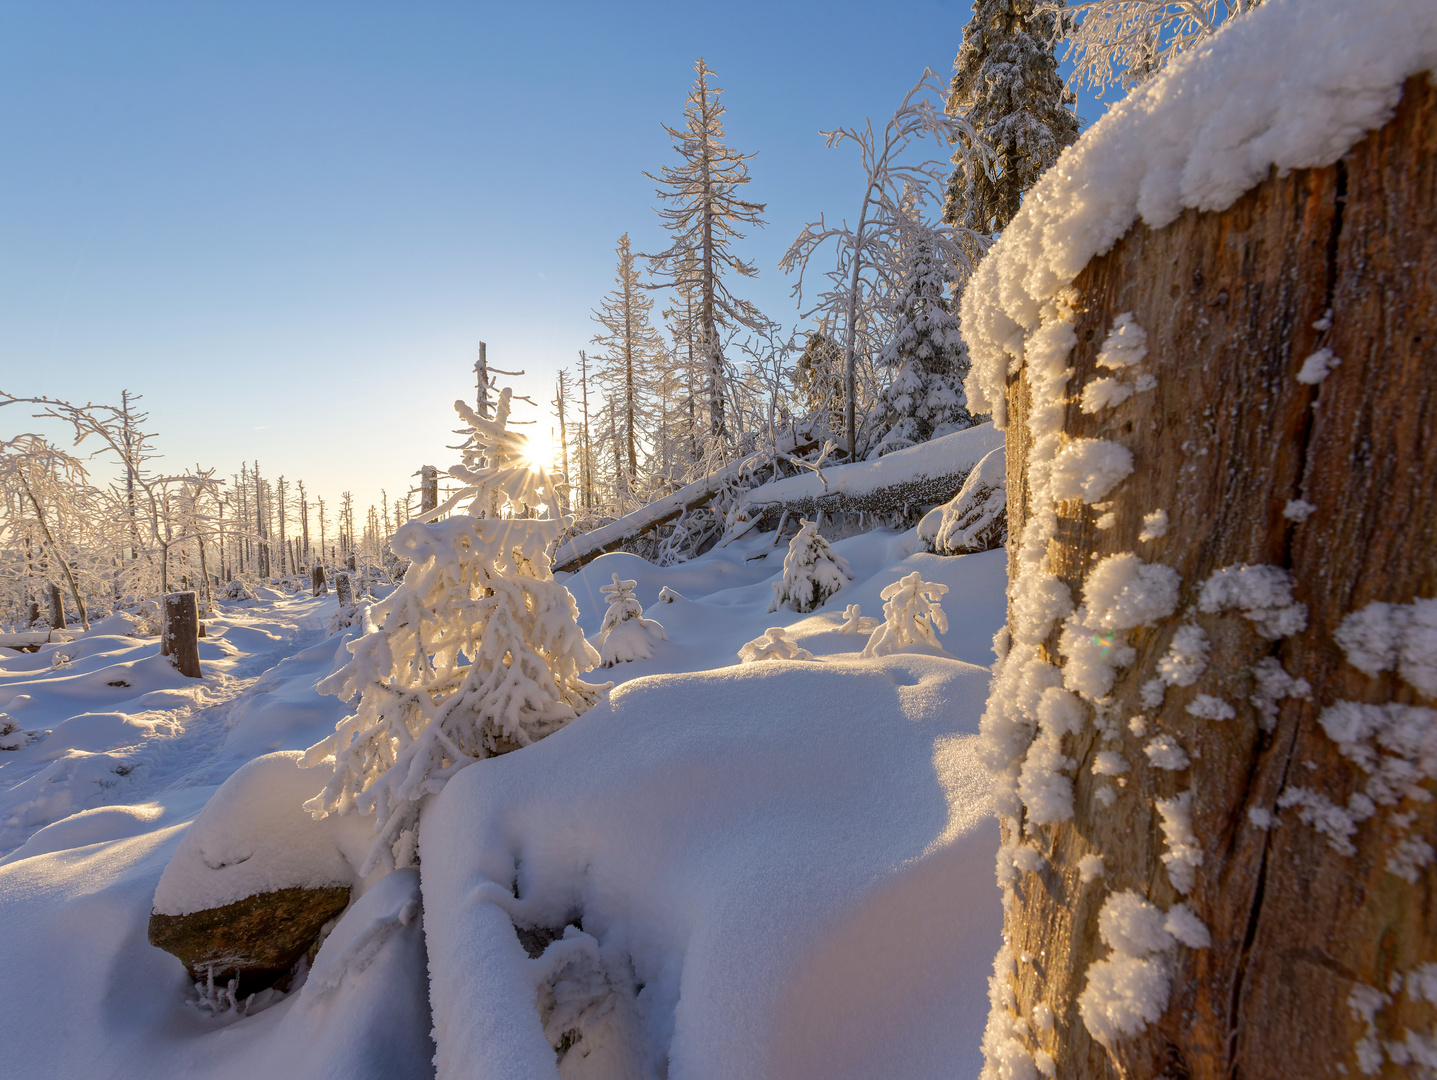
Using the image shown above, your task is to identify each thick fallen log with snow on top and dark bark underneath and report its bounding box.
[729,424,1003,536]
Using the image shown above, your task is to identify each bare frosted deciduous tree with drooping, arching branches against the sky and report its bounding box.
[779,69,987,457]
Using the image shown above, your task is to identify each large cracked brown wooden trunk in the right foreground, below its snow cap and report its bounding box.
[1000,78,1437,1077]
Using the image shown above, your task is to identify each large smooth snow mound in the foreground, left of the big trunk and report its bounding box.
[421,655,1002,1080]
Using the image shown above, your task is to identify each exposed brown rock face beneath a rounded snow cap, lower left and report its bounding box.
[149,886,349,995]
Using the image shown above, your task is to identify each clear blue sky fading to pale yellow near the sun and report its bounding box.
[0,0,1000,522]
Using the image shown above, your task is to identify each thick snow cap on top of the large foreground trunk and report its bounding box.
[963,0,1437,428]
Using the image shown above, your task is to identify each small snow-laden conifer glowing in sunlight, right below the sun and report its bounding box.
[305,389,606,875]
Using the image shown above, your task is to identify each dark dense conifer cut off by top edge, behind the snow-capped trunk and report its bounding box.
[943,0,1078,236]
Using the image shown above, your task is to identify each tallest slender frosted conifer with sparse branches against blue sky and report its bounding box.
[644,57,763,439]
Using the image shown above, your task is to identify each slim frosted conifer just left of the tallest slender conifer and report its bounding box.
[593,233,664,497]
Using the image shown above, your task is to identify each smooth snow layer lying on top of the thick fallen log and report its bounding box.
[740,424,1003,513]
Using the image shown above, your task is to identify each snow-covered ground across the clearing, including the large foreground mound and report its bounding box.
[0,531,1006,1080]
